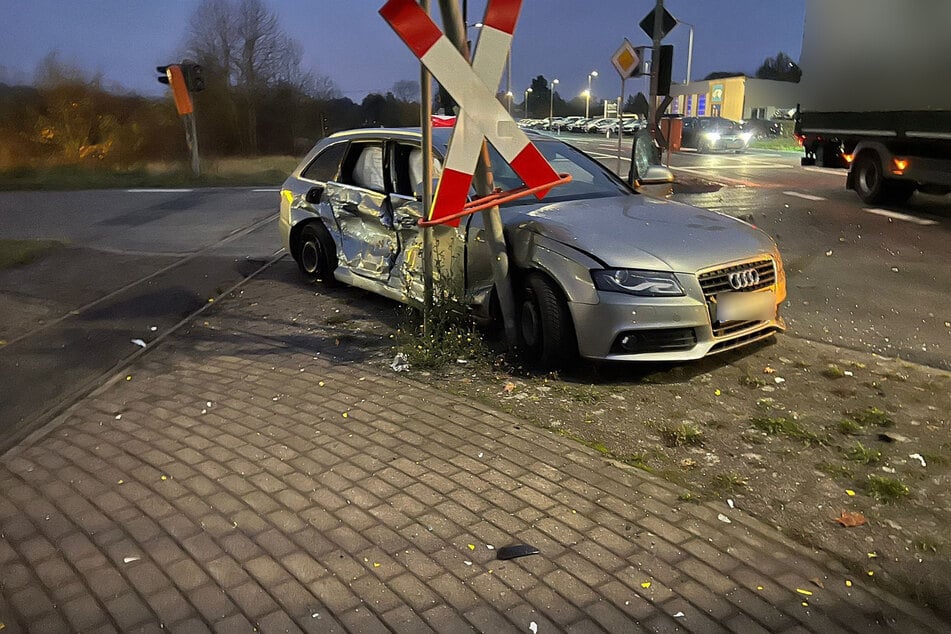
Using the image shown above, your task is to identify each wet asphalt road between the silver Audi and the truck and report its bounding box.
[564,135,951,369]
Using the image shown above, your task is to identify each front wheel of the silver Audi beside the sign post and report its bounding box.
[518,273,578,371]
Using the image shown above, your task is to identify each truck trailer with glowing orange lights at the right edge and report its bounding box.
[796,0,951,204]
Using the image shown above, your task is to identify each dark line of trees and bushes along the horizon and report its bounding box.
[0,0,798,170]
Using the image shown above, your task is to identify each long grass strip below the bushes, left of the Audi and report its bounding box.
[0,156,299,190]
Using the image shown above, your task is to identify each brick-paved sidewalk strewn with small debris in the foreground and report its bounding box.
[0,270,947,634]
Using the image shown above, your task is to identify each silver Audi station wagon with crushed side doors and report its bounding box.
[279,128,786,368]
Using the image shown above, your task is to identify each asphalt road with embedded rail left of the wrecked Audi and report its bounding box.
[0,188,280,450]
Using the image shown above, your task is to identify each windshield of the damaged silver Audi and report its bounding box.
[489,140,631,207]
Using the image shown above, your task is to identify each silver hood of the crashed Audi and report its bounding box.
[505,195,775,273]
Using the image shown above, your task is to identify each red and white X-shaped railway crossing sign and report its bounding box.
[380,0,561,224]
